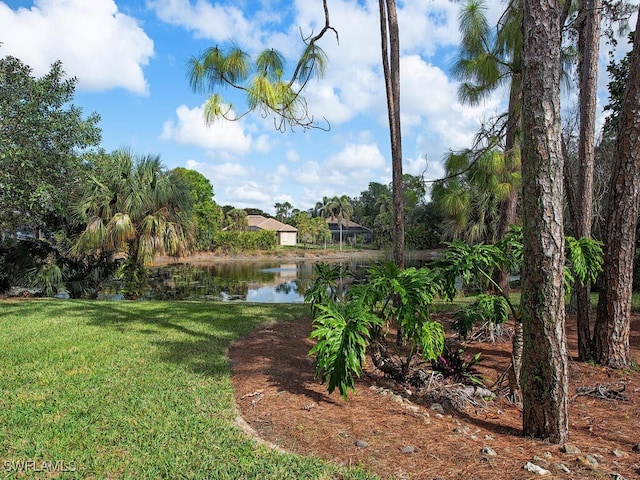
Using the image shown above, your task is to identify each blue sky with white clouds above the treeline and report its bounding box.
[0,0,626,213]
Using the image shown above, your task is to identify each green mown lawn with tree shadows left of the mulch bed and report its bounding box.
[0,300,375,480]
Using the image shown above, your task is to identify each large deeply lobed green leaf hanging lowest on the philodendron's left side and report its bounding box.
[309,299,382,398]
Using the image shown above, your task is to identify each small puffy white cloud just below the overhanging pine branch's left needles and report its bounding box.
[160,105,252,154]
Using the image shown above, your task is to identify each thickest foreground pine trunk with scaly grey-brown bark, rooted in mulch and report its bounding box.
[521,0,569,443]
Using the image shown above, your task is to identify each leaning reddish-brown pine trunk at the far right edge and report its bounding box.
[594,13,640,368]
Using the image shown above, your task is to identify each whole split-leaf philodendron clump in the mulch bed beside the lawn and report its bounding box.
[305,262,445,396]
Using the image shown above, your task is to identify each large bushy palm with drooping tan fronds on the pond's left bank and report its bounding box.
[74,148,195,297]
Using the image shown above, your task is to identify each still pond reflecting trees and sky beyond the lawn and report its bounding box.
[100,253,440,303]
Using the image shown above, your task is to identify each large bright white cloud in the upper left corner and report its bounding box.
[0,0,154,94]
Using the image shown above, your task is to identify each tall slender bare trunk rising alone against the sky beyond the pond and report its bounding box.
[379,0,404,268]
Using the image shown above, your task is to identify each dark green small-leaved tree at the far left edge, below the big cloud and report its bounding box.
[0,56,101,233]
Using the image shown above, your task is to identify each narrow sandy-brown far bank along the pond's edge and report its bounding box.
[153,249,438,267]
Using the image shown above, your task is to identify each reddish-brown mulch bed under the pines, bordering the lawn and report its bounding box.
[229,315,640,480]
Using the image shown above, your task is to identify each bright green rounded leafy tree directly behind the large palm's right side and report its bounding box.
[173,167,224,250]
